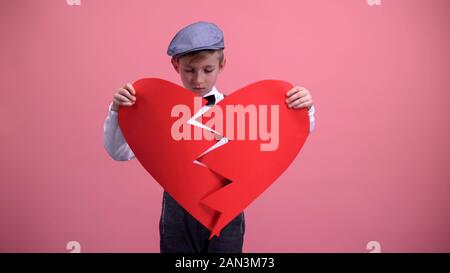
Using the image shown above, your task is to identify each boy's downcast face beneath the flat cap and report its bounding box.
[172,51,226,96]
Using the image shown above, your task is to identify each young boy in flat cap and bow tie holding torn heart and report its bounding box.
[104,22,314,253]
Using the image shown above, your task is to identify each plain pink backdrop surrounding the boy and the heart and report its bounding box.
[0,0,450,252]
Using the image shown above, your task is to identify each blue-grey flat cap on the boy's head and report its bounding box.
[167,22,225,56]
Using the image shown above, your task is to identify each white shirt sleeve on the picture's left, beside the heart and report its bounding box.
[103,103,135,161]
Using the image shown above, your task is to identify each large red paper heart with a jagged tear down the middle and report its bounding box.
[119,79,309,237]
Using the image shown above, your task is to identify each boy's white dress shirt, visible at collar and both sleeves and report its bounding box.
[103,87,315,161]
